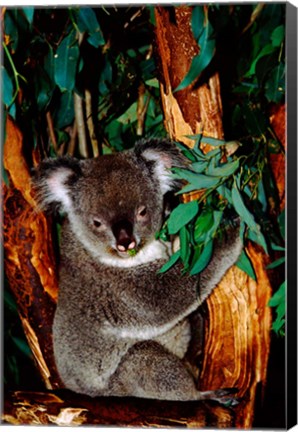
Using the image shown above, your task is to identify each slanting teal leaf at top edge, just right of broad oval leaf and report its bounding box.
[77,7,105,48]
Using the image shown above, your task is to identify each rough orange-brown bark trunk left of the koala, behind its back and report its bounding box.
[3,117,59,389]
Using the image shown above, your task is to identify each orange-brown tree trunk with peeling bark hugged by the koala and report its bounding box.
[155,6,271,428]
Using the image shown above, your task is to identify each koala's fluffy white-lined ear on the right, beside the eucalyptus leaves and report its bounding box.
[134,138,189,194]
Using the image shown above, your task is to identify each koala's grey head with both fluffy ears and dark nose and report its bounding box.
[33,139,186,260]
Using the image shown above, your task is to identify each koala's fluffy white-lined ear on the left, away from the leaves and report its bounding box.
[32,157,82,212]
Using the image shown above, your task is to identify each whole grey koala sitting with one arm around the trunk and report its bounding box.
[33,139,242,401]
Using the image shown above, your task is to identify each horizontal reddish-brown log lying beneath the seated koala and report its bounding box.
[3,391,233,428]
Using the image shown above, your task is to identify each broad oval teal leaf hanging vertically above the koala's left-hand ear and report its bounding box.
[54,31,80,91]
